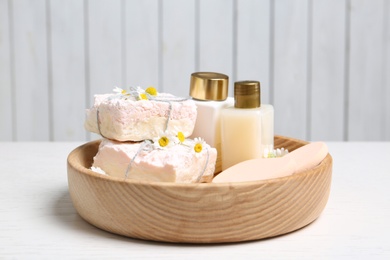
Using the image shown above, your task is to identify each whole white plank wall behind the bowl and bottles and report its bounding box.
[0,0,390,141]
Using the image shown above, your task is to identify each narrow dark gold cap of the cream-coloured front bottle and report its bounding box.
[234,80,261,108]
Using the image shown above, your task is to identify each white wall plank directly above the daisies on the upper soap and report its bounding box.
[125,0,161,89]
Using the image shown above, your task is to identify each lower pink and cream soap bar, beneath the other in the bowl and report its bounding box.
[92,139,217,183]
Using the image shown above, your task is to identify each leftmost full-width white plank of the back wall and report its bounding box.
[12,0,50,141]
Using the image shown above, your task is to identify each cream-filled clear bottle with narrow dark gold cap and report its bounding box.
[221,81,274,170]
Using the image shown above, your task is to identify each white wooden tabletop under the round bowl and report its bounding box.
[0,142,390,260]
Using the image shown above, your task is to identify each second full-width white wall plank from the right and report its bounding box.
[308,0,346,141]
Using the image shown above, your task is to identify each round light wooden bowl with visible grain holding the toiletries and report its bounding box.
[68,137,332,243]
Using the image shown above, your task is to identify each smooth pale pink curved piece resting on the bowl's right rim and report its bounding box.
[212,142,328,183]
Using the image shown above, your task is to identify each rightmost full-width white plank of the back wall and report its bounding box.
[348,0,388,141]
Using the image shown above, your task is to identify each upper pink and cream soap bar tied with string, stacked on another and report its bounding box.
[84,93,197,141]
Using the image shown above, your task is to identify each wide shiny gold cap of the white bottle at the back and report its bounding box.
[190,72,229,101]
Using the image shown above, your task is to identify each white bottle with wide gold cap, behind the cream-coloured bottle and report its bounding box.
[190,72,234,172]
